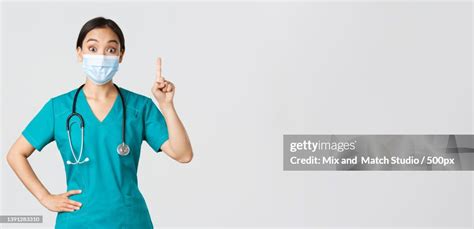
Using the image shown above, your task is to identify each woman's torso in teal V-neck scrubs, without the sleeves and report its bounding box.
[54,89,153,228]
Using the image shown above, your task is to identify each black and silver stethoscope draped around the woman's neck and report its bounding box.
[66,84,130,165]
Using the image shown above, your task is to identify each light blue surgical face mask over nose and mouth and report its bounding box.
[82,54,119,85]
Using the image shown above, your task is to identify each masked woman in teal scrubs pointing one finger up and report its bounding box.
[7,17,193,228]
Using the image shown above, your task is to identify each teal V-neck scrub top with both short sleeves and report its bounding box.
[22,87,169,228]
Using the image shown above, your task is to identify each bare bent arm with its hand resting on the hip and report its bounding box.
[7,135,81,212]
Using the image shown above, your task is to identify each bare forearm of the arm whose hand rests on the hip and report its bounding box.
[7,153,50,201]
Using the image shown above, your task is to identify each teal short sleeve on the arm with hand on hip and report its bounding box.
[22,99,54,151]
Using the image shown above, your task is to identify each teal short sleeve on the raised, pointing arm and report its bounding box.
[143,98,169,153]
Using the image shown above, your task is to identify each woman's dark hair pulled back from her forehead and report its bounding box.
[76,17,125,51]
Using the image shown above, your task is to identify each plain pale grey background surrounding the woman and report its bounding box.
[0,1,474,228]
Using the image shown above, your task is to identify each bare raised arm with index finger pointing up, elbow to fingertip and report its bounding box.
[151,58,193,163]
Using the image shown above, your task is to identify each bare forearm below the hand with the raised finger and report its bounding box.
[160,103,192,158]
